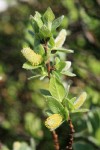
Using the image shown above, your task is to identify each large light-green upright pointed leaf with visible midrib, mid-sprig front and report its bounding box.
[49,76,66,102]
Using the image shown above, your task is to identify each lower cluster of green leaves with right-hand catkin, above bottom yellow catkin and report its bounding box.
[41,76,88,129]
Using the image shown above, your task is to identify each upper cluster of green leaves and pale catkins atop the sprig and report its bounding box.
[22,8,74,79]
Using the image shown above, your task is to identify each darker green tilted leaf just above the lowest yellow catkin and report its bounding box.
[47,96,65,115]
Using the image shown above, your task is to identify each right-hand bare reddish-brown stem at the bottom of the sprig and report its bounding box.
[66,117,75,150]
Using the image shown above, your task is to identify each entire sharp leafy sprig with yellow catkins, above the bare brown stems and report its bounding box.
[21,8,88,150]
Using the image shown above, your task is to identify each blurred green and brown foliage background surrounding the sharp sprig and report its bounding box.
[0,0,100,150]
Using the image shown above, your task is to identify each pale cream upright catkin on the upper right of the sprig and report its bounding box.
[55,29,67,48]
